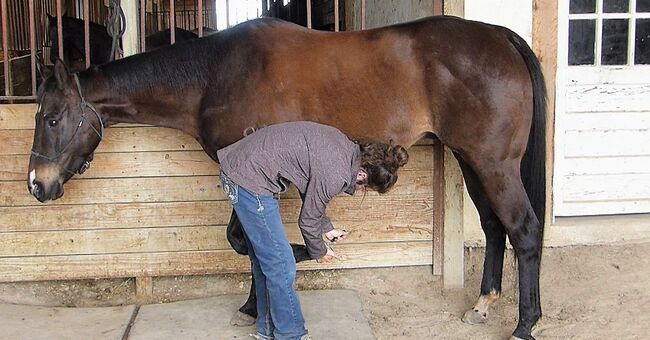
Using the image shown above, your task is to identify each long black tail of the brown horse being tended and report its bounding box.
[508,31,546,247]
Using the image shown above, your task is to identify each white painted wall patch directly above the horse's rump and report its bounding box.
[465,0,533,45]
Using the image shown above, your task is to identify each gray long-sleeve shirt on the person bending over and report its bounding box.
[217,122,361,259]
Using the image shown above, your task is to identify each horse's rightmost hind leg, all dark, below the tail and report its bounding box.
[460,159,542,339]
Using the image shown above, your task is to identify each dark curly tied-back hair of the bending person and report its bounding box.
[357,141,409,194]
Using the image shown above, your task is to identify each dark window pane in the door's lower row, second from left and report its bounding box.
[600,19,627,65]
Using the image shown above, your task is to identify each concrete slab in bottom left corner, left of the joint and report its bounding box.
[0,304,135,340]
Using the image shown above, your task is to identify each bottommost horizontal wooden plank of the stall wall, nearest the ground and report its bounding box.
[0,241,432,282]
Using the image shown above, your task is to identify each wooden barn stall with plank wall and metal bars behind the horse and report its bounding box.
[0,0,463,299]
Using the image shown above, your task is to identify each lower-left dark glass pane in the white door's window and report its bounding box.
[569,20,596,65]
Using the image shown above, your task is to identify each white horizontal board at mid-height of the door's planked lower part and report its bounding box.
[563,129,650,157]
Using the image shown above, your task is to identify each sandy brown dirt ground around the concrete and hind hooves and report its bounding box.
[0,243,650,339]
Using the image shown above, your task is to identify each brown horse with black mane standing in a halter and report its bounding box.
[28,17,546,339]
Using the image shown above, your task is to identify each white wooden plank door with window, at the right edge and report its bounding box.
[553,2,650,216]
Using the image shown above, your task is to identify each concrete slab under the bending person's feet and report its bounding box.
[129,290,374,340]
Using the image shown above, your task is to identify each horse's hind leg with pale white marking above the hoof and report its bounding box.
[454,153,506,325]
